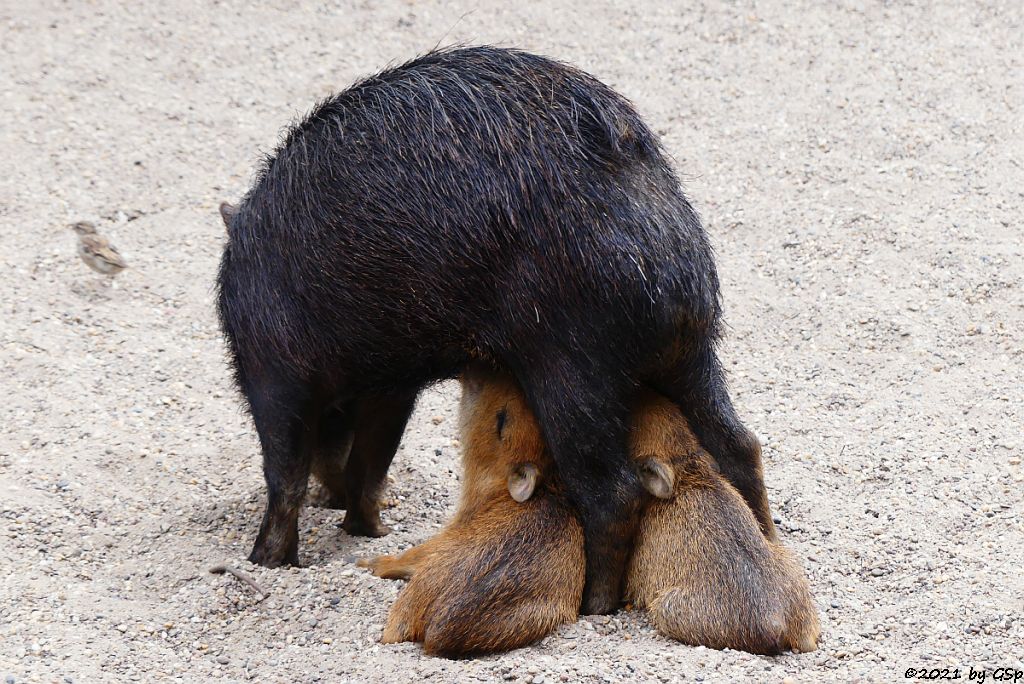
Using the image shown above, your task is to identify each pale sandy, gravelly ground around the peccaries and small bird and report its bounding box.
[0,0,1024,682]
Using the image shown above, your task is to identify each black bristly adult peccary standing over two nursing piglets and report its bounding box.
[219,47,774,612]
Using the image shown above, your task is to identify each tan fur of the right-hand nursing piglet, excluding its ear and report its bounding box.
[626,393,820,653]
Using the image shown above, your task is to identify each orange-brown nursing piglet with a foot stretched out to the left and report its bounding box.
[359,372,586,656]
